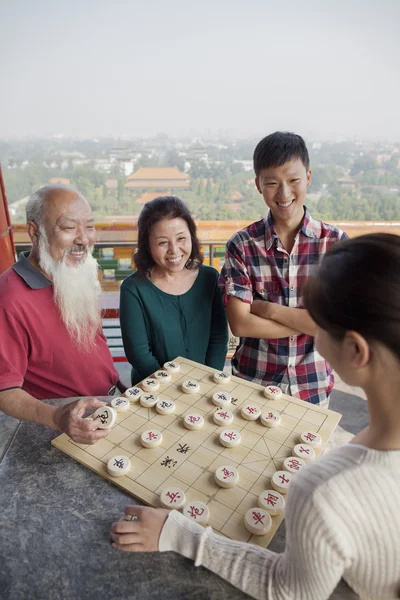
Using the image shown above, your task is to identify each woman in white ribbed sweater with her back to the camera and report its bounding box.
[112,233,400,600]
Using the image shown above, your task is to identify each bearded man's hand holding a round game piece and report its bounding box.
[53,398,109,444]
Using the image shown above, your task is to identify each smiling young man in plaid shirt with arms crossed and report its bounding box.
[219,132,347,406]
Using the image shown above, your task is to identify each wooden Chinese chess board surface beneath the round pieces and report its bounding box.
[52,357,341,546]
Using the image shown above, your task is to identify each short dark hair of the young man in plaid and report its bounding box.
[253,131,310,177]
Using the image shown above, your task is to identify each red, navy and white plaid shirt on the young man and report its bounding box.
[219,208,348,404]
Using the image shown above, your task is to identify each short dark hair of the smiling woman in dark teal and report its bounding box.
[133,196,203,274]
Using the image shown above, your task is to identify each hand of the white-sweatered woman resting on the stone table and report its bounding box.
[111,506,169,552]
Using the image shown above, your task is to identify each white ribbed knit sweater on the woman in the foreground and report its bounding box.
[159,444,400,600]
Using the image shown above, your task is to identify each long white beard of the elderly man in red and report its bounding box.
[39,228,101,351]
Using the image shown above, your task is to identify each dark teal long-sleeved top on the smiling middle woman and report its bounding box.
[120,265,228,385]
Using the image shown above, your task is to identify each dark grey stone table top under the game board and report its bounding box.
[0,399,358,600]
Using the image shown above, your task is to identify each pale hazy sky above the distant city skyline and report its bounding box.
[0,0,400,140]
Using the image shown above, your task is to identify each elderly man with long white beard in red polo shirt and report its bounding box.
[0,185,122,444]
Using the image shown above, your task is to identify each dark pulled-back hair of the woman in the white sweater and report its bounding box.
[304,233,400,359]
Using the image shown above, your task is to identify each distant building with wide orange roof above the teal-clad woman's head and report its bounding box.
[125,167,190,197]
